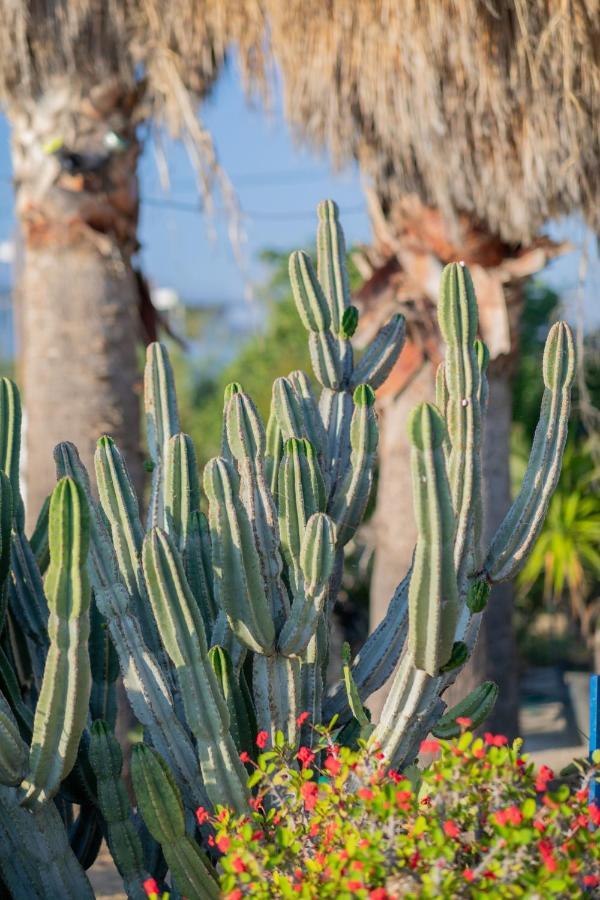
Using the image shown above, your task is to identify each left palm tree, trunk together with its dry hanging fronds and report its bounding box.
[0,0,253,516]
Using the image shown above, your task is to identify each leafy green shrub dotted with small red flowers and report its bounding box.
[204,719,600,900]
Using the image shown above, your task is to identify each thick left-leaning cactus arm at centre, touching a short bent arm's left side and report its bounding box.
[204,458,275,653]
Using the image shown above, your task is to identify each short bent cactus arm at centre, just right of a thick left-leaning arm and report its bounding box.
[278,513,335,656]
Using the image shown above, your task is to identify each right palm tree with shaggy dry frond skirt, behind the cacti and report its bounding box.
[226,0,600,733]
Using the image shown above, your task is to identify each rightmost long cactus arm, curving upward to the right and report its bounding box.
[484,322,575,582]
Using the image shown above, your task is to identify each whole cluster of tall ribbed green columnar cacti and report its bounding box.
[0,202,574,900]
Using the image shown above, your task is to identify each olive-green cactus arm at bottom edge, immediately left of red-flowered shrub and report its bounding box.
[131,744,219,900]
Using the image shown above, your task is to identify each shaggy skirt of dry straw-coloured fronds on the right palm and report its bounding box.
[247,0,600,242]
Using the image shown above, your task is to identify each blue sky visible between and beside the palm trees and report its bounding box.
[0,67,600,324]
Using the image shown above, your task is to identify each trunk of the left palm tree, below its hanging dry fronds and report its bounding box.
[10,79,142,524]
